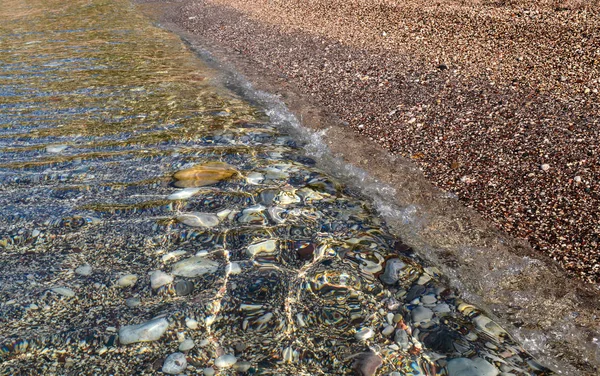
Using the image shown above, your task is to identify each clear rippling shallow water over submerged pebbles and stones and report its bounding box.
[0,0,551,376]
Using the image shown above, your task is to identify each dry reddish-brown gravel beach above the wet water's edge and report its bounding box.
[154,0,600,283]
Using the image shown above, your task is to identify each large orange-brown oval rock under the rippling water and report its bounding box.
[173,162,237,188]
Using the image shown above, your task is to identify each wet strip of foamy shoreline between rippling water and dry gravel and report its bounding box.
[137,2,600,375]
